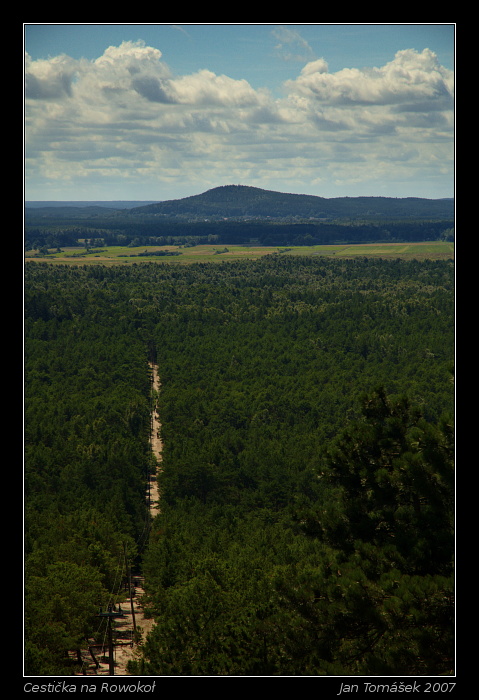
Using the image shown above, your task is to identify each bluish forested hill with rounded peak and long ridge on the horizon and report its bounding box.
[130,185,454,219]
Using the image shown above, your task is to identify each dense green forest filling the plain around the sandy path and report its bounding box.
[25,256,454,676]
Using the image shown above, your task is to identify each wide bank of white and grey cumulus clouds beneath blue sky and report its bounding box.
[25,39,454,198]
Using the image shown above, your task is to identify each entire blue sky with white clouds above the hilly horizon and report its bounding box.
[24,24,455,201]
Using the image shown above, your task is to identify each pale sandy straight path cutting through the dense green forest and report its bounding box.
[81,363,163,676]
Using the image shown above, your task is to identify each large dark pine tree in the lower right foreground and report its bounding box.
[288,389,454,675]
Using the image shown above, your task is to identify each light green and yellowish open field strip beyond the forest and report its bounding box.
[25,241,454,265]
